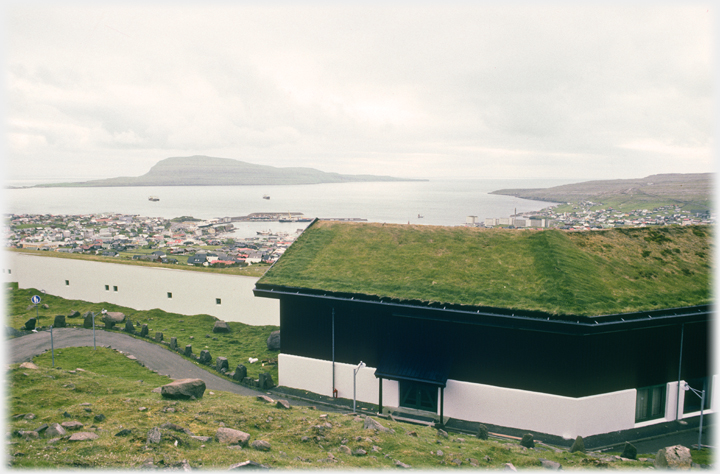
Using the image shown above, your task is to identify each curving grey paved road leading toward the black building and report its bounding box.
[7,328,265,396]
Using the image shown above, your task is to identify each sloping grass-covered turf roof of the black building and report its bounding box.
[258,221,712,316]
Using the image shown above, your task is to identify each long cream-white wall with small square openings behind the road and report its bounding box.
[4,252,280,326]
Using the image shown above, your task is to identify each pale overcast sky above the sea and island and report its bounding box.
[3,2,716,181]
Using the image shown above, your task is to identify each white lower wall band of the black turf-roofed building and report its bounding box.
[278,354,717,439]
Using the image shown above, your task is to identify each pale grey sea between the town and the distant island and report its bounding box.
[4,179,579,238]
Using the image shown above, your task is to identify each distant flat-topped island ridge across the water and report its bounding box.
[35,155,425,188]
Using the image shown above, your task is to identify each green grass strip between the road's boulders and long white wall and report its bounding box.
[6,286,279,382]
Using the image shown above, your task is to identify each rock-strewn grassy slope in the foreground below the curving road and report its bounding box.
[6,348,668,470]
